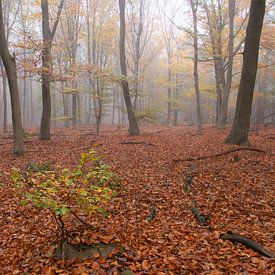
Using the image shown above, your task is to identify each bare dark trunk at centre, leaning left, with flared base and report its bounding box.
[119,0,139,135]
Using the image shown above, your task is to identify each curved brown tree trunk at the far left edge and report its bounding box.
[0,0,25,156]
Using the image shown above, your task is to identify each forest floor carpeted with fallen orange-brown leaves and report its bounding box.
[0,126,275,275]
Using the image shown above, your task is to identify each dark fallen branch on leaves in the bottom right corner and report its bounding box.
[220,232,275,258]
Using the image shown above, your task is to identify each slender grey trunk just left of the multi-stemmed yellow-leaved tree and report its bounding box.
[190,0,202,135]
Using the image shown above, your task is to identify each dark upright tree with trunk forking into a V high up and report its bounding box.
[40,0,64,140]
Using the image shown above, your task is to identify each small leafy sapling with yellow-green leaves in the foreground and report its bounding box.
[11,150,114,242]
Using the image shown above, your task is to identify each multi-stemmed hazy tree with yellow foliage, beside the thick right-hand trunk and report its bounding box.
[202,0,248,128]
